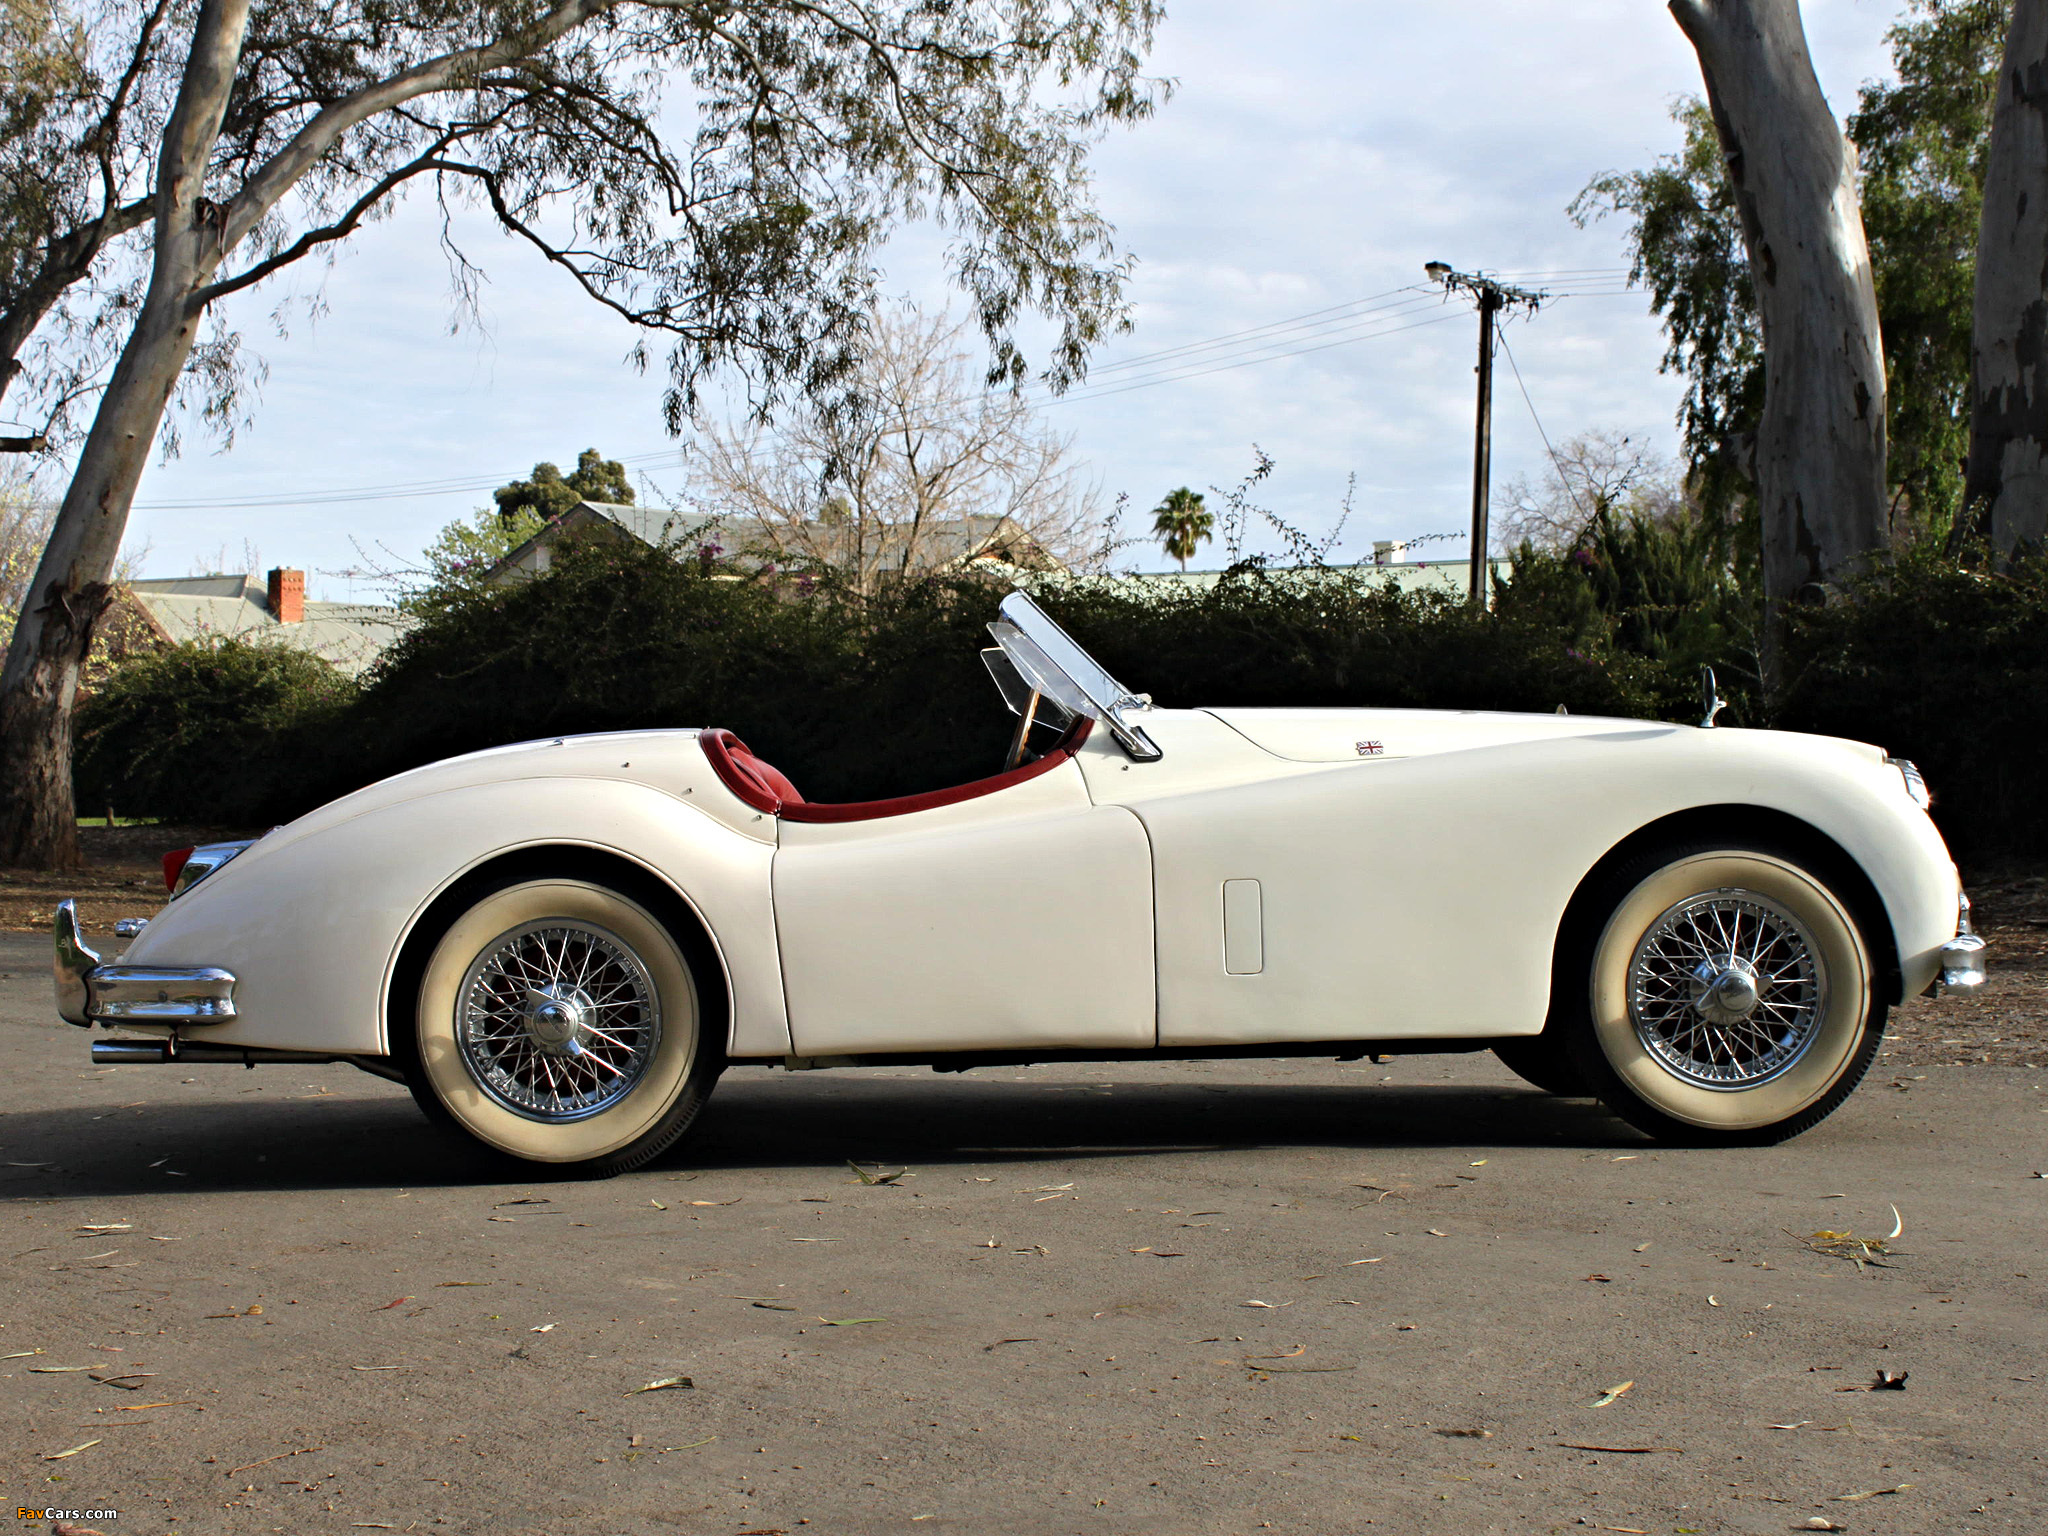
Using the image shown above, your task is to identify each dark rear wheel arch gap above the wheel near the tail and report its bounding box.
[381,842,733,1059]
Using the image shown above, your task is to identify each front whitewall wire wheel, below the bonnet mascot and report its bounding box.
[1561,846,1886,1145]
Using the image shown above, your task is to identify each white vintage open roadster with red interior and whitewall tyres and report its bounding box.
[55,594,1985,1171]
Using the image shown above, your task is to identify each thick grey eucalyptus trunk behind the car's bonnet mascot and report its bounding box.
[1671,0,1890,637]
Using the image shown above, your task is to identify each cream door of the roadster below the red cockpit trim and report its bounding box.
[774,762,1157,1057]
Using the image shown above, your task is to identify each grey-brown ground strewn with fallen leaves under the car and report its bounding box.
[0,921,2048,1536]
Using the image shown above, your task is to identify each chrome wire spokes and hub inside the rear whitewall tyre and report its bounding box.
[457,922,662,1122]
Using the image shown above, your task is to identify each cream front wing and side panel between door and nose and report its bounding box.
[1083,711,1958,1049]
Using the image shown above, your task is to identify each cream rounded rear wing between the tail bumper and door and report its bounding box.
[108,776,788,1057]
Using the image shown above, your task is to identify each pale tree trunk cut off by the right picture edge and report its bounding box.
[1964,0,2048,553]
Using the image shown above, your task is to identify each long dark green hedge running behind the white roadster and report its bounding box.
[78,526,2048,854]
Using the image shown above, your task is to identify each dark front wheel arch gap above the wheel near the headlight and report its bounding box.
[1550,803,1905,1018]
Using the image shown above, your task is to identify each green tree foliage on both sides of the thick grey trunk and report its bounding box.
[1571,0,2011,541]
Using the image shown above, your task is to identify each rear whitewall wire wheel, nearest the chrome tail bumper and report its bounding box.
[408,874,725,1176]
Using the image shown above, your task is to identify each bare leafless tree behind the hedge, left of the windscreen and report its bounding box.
[690,309,1102,592]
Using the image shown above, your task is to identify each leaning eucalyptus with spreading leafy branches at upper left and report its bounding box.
[0,0,1159,864]
